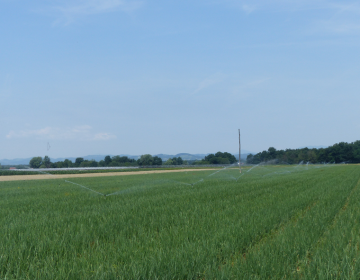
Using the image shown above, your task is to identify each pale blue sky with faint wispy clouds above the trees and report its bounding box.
[0,0,360,159]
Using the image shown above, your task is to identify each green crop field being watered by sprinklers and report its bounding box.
[0,165,360,279]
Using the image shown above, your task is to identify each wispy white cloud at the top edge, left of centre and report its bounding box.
[38,0,143,25]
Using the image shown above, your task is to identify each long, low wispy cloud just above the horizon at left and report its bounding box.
[6,125,116,141]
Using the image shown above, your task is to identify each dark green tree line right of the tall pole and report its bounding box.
[247,140,360,164]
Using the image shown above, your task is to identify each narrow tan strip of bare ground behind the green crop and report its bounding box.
[0,168,212,182]
